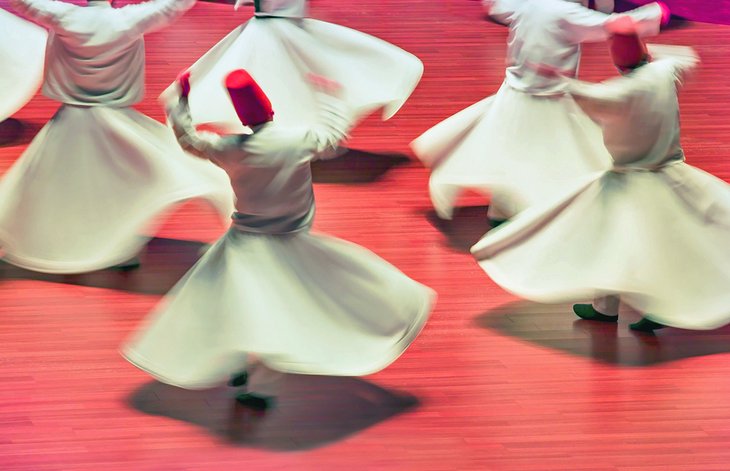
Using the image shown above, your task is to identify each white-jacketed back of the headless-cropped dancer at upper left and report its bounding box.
[13,0,195,107]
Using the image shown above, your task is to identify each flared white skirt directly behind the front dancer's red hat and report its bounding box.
[162,0,423,132]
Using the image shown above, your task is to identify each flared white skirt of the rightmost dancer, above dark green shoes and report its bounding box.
[472,163,730,329]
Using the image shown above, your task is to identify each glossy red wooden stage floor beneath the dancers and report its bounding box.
[0,0,730,471]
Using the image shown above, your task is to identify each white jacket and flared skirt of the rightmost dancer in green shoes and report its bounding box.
[472,37,730,331]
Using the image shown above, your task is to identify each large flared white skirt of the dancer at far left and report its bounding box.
[0,106,234,273]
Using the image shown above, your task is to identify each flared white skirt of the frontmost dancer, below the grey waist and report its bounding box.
[122,229,435,389]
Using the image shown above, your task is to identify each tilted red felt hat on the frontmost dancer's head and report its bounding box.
[225,69,274,126]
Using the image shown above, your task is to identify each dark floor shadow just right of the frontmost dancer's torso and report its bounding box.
[312,148,411,183]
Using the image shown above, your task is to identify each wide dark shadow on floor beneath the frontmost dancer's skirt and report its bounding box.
[129,375,418,451]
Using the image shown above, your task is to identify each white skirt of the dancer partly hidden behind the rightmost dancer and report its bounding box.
[411,84,611,219]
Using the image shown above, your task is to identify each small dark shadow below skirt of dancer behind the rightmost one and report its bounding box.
[426,206,492,253]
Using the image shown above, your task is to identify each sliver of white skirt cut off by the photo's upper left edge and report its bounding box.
[0,8,48,122]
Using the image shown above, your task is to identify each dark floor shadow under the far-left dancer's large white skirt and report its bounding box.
[0,238,206,295]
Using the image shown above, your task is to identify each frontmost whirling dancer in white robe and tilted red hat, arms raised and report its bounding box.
[123,70,435,398]
